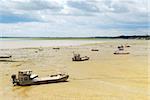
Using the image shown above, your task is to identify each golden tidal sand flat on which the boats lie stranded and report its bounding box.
[0,40,150,100]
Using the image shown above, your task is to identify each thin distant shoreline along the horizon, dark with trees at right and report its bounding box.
[0,35,150,40]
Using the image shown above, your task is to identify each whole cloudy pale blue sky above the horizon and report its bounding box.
[0,0,150,37]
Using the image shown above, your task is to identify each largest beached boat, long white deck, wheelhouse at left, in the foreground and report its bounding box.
[11,70,69,86]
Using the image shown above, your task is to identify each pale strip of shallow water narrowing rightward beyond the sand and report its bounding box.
[0,38,107,49]
